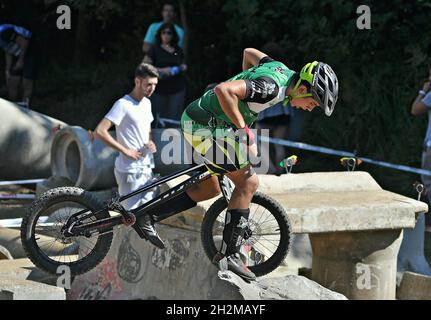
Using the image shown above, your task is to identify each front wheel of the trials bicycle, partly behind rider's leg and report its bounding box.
[201,192,291,276]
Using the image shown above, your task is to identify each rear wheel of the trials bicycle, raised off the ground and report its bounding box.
[21,187,113,276]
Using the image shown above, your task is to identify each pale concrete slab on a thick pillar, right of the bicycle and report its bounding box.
[261,172,428,299]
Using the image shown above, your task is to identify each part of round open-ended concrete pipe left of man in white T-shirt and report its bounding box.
[51,126,118,190]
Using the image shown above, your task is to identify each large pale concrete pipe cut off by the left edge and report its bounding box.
[0,98,66,180]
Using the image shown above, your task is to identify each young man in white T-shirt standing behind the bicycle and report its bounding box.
[94,63,164,249]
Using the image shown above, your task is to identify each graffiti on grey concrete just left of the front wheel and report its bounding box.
[151,239,190,270]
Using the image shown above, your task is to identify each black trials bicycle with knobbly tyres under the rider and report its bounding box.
[21,164,291,276]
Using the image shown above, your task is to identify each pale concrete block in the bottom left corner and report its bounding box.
[0,278,66,300]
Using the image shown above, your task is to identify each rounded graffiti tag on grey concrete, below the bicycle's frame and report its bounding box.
[117,230,144,283]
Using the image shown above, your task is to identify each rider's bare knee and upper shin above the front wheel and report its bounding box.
[227,166,259,209]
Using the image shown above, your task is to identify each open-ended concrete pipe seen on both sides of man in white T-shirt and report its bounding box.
[51,126,191,190]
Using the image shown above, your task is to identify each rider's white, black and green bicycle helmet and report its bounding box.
[293,61,338,117]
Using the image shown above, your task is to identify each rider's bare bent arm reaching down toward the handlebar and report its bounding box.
[214,80,247,128]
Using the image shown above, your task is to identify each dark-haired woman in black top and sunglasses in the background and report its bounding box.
[144,23,187,126]
